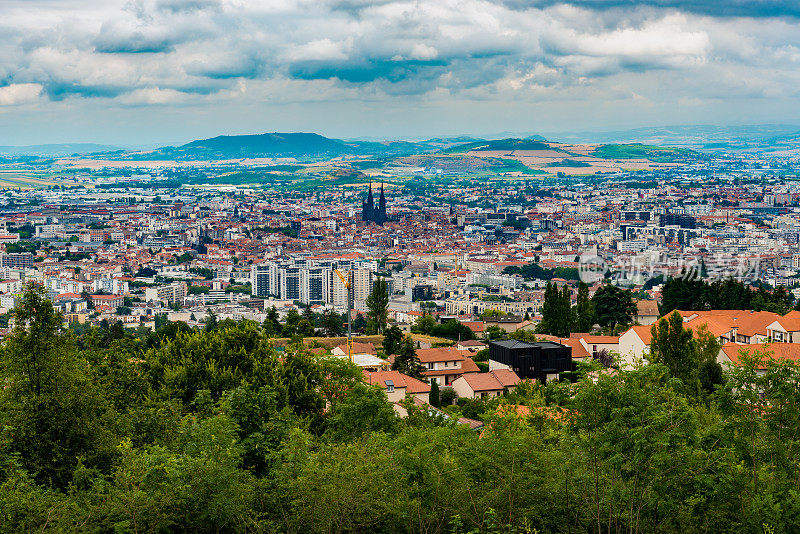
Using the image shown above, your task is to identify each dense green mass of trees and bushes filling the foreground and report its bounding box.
[0,289,800,533]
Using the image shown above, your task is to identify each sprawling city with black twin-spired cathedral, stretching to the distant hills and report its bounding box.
[0,132,800,344]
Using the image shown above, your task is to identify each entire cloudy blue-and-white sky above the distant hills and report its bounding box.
[0,0,800,145]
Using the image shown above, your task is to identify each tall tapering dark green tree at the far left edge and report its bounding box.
[0,284,118,488]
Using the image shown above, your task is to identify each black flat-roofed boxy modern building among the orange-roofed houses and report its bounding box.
[489,339,572,382]
